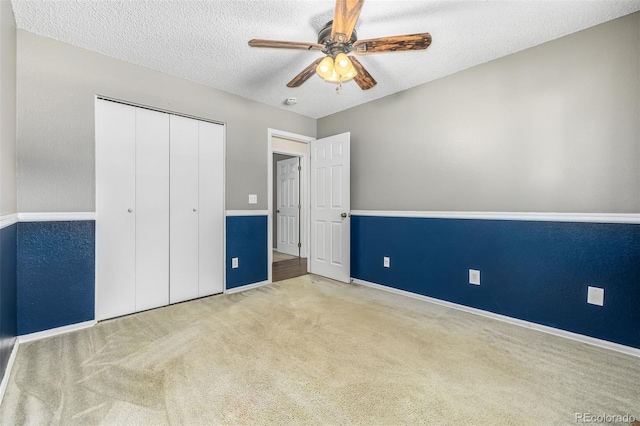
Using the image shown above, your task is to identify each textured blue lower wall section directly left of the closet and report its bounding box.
[17,221,95,335]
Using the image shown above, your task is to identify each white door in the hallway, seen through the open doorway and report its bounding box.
[276,157,300,256]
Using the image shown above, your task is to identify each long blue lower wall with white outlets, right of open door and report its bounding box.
[351,216,640,348]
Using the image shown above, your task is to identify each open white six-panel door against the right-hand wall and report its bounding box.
[310,133,351,282]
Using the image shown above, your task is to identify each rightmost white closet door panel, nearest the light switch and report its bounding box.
[199,121,225,297]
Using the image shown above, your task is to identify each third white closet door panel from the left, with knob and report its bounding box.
[169,115,199,303]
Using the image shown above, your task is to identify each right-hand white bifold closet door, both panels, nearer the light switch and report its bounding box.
[170,115,224,303]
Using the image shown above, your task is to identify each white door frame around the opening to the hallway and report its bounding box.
[267,128,316,283]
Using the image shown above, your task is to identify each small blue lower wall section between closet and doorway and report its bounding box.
[226,216,269,289]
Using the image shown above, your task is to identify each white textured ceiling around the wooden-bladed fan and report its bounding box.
[12,0,640,118]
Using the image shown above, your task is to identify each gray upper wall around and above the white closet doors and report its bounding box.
[19,30,316,212]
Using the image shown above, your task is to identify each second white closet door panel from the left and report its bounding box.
[135,108,169,311]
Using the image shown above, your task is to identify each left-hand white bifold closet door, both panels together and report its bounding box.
[96,100,169,320]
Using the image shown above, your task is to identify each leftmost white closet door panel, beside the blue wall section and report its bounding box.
[95,100,136,320]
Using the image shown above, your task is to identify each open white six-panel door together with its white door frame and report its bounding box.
[267,129,351,282]
